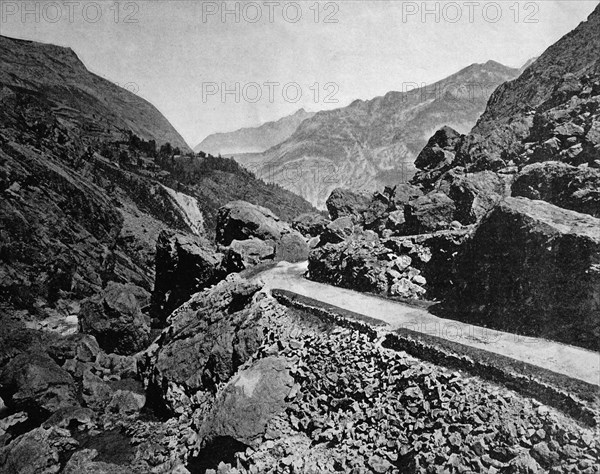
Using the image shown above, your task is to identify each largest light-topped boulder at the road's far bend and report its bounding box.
[216,201,291,246]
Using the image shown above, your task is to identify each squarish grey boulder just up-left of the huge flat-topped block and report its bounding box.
[404,192,456,234]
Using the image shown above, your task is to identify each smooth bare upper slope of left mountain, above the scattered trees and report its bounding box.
[0,36,189,151]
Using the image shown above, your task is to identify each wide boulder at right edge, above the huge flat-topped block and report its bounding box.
[512,161,600,217]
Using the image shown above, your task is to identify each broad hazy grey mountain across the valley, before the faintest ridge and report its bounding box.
[236,61,519,208]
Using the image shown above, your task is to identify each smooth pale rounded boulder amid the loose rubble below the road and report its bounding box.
[199,356,294,446]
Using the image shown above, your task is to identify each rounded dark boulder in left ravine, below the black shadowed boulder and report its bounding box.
[79,282,150,354]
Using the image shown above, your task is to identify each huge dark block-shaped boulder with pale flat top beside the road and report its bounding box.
[454,198,600,350]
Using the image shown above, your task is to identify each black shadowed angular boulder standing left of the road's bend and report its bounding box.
[152,230,225,321]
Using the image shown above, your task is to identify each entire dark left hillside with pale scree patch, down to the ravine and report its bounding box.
[0,38,312,324]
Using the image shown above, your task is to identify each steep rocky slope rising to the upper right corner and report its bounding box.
[446,4,600,172]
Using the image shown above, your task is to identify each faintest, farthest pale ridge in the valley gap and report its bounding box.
[194,109,314,155]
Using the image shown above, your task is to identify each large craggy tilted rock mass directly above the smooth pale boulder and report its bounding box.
[141,274,263,410]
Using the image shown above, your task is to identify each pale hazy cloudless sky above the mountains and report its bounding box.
[0,0,597,146]
